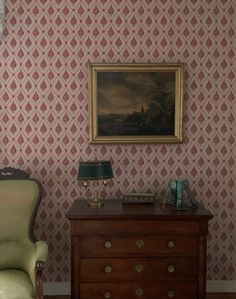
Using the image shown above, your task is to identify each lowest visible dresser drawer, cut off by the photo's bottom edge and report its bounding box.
[80,281,198,299]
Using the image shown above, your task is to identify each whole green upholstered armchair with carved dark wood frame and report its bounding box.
[0,169,48,299]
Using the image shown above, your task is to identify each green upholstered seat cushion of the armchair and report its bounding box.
[0,270,35,299]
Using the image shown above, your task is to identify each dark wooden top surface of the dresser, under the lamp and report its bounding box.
[66,199,212,220]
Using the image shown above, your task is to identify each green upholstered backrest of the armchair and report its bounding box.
[0,177,41,270]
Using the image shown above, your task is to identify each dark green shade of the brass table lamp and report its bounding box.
[77,161,113,180]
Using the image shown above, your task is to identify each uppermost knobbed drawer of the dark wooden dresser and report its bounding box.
[80,235,198,257]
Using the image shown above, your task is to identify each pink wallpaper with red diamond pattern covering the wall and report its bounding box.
[0,0,236,281]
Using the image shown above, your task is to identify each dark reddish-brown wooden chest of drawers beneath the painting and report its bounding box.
[67,200,212,299]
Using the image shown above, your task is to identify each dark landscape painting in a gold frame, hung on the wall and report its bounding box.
[89,64,184,143]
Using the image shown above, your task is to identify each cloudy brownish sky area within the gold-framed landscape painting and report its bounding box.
[97,72,175,115]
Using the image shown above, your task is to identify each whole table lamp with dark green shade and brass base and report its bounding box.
[77,161,113,207]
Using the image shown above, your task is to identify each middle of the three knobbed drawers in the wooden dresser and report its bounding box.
[80,258,198,282]
